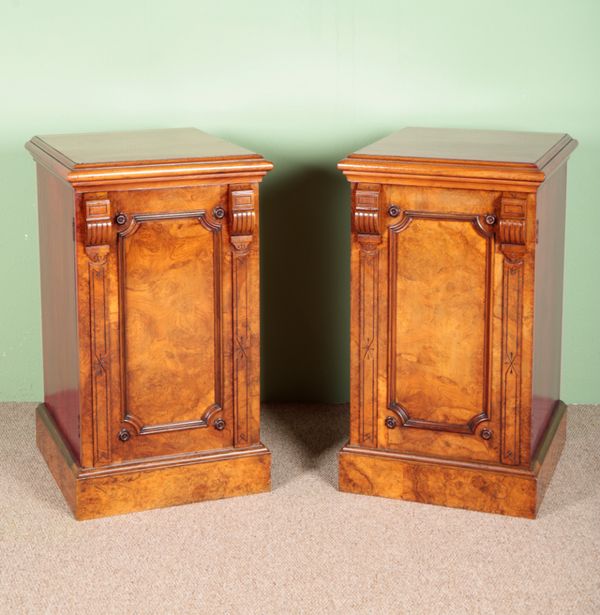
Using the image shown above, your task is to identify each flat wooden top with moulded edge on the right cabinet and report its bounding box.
[338,128,577,188]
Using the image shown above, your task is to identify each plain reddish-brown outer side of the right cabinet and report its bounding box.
[531,164,567,455]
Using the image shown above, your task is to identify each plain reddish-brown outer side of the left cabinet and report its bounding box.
[37,164,80,459]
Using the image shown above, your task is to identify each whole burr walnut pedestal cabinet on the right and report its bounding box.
[339,128,576,517]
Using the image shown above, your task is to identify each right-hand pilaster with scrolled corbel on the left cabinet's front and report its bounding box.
[229,185,256,446]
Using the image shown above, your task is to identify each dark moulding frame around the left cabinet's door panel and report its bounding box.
[118,210,223,435]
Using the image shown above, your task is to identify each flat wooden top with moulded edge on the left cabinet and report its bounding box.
[26,128,273,183]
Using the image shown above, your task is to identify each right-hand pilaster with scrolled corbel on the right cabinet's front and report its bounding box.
[497,192,527,465]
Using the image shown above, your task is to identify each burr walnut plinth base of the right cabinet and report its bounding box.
[339,402,567,519]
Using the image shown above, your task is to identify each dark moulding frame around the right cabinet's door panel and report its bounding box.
[387,211,495,434]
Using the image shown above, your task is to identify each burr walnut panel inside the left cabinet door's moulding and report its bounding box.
[121,218,220,431]
